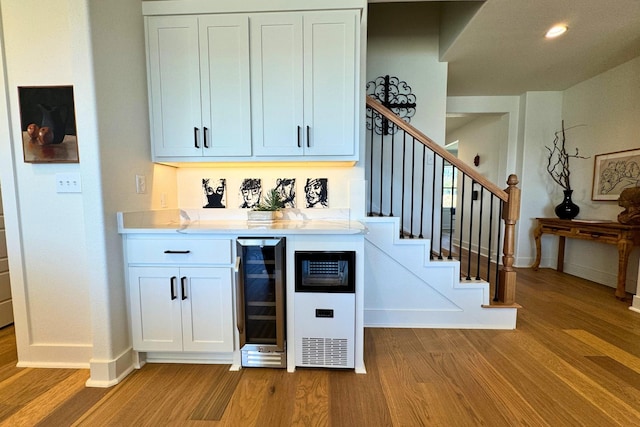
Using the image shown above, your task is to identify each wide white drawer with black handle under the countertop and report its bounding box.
[127,239,231,265]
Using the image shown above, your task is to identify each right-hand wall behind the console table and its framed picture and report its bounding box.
[554,57,640,292]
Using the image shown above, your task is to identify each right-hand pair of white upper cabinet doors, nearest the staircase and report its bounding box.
[250,10,359,157]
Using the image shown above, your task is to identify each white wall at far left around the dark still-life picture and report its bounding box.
[0,0,92,366]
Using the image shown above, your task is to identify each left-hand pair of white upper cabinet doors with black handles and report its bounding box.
[147,15,251,160]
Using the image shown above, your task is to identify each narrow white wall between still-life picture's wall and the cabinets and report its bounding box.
[82,0,158,386]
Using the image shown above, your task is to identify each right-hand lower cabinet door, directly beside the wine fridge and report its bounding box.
[180,268,233,352]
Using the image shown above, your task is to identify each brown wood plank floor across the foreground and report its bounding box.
[0,269,640,427]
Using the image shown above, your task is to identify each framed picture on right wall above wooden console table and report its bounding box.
[591,148,640,200]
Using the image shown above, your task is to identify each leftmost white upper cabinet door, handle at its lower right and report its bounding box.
[147,16,202,157]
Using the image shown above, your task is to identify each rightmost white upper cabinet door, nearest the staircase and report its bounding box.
[304,11,358,156]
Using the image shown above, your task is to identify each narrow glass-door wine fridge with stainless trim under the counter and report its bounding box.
[236,237,287,368]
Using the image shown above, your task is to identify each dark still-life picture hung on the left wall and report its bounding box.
[18,86,80,163]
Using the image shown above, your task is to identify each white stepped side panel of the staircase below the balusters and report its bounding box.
[364,218,517,329]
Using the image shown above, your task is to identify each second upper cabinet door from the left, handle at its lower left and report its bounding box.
[198,15,251,156]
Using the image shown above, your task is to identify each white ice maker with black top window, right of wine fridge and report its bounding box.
[294,251,356,368]
